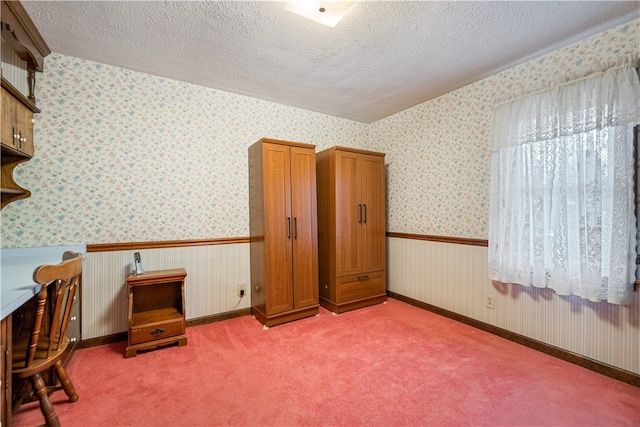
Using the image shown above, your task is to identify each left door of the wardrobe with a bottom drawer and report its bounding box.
[335,151,363,277]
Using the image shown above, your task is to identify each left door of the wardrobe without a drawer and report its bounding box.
[263,144,293,315]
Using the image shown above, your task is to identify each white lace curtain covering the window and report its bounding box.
[489,65,640,304]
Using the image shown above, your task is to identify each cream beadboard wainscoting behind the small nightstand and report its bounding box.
[82,238,251,340]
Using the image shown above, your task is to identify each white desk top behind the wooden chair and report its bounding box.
[0,245,87,319]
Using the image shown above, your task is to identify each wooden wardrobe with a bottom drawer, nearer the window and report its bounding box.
[316,147,387,313]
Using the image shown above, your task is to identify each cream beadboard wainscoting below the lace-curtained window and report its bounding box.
[387,237,640,375]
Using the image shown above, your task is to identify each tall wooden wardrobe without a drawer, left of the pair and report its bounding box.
[249,138,319,326]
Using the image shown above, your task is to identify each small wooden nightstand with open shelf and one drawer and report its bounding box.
[125,268,187,357]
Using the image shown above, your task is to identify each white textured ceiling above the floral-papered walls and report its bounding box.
[22,0,640,123]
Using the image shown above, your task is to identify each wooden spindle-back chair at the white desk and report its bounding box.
[12,252,82,426]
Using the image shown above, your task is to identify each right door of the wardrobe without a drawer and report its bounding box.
[291,147,318,308]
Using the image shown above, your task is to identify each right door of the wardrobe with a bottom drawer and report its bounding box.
[362,156,387,271]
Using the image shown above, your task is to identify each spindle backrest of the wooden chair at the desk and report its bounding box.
[25,252,82,367]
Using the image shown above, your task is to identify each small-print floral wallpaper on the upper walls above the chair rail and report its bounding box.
[1,20,640,248]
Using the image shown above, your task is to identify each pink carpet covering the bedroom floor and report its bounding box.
[14,299,640,427]
